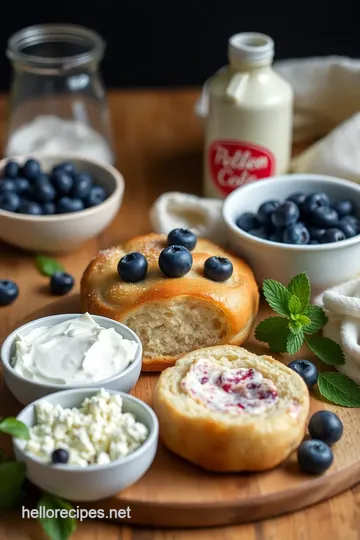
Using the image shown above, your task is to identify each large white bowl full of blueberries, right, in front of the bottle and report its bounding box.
[223,174,360,293]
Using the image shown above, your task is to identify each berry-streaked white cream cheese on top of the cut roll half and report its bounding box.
[181,358,279,414]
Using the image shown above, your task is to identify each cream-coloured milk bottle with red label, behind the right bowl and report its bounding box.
[204,33,293,198]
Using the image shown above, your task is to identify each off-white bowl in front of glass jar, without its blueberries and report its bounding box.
[0,154,124,253]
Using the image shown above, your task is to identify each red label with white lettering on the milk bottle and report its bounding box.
[208,140,275,195]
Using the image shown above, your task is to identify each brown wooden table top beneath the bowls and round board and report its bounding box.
[0,90,360,540]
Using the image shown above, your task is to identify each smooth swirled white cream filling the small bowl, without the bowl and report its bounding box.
[12,313,138,384]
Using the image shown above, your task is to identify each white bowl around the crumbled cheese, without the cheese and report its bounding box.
[13,387,159,502]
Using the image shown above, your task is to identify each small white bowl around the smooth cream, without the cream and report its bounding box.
[1,313,142,405]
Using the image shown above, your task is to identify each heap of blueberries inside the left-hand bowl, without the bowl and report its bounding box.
[0,159,107,216]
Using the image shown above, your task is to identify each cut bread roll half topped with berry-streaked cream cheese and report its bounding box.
[153,345,309,472]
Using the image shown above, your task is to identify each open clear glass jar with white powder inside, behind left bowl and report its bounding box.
[5,24,115,163]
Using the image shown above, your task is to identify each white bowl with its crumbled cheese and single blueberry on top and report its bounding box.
[13,388,159,502]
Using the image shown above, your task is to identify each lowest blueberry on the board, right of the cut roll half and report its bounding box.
[297,439,334,474]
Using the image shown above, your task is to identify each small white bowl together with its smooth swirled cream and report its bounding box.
[1,313,142,405]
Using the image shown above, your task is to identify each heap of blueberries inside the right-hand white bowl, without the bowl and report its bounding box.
[236,193,360,245]
